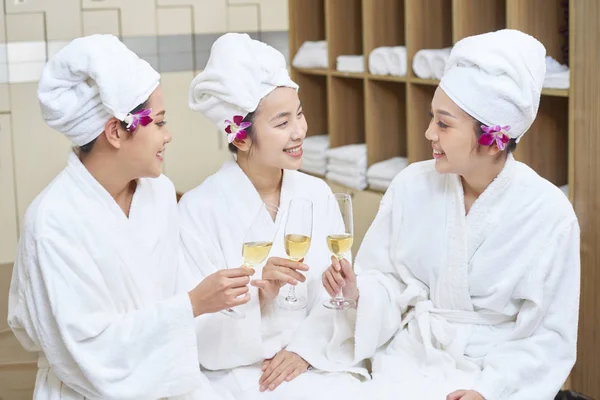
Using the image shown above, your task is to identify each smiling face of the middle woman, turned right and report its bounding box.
[234,87,307,170]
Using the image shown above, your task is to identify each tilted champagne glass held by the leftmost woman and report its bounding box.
[221,203,279,319]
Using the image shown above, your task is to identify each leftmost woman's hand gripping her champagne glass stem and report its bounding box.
[188,268,255,317]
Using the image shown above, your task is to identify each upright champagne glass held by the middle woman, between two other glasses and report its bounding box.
[277,199,313,311]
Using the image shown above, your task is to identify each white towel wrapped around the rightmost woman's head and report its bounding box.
[439,29,546,142]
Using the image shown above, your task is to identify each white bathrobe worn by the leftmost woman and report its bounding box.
[8,153,232,400]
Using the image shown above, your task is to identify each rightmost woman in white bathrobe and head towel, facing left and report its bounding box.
[316,30,580,400]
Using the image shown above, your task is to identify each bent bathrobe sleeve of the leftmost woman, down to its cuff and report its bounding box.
[8,231,203,399]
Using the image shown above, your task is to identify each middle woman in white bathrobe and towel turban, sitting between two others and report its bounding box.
[179,33,366,399]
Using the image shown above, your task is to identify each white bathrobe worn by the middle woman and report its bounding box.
[179,161,366,400]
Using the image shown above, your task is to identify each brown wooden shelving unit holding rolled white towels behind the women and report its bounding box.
[289,0,600,398]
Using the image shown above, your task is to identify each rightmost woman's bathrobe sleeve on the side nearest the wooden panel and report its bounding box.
[472,221,580,400]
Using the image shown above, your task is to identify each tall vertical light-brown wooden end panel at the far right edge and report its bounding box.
[570,0,600,399]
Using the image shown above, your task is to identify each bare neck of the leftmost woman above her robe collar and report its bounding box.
[79,152,135,215]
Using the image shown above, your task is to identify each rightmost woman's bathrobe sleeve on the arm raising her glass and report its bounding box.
[288,182,406,377]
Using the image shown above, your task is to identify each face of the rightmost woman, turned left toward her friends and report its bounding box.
[425,87,499,176]
